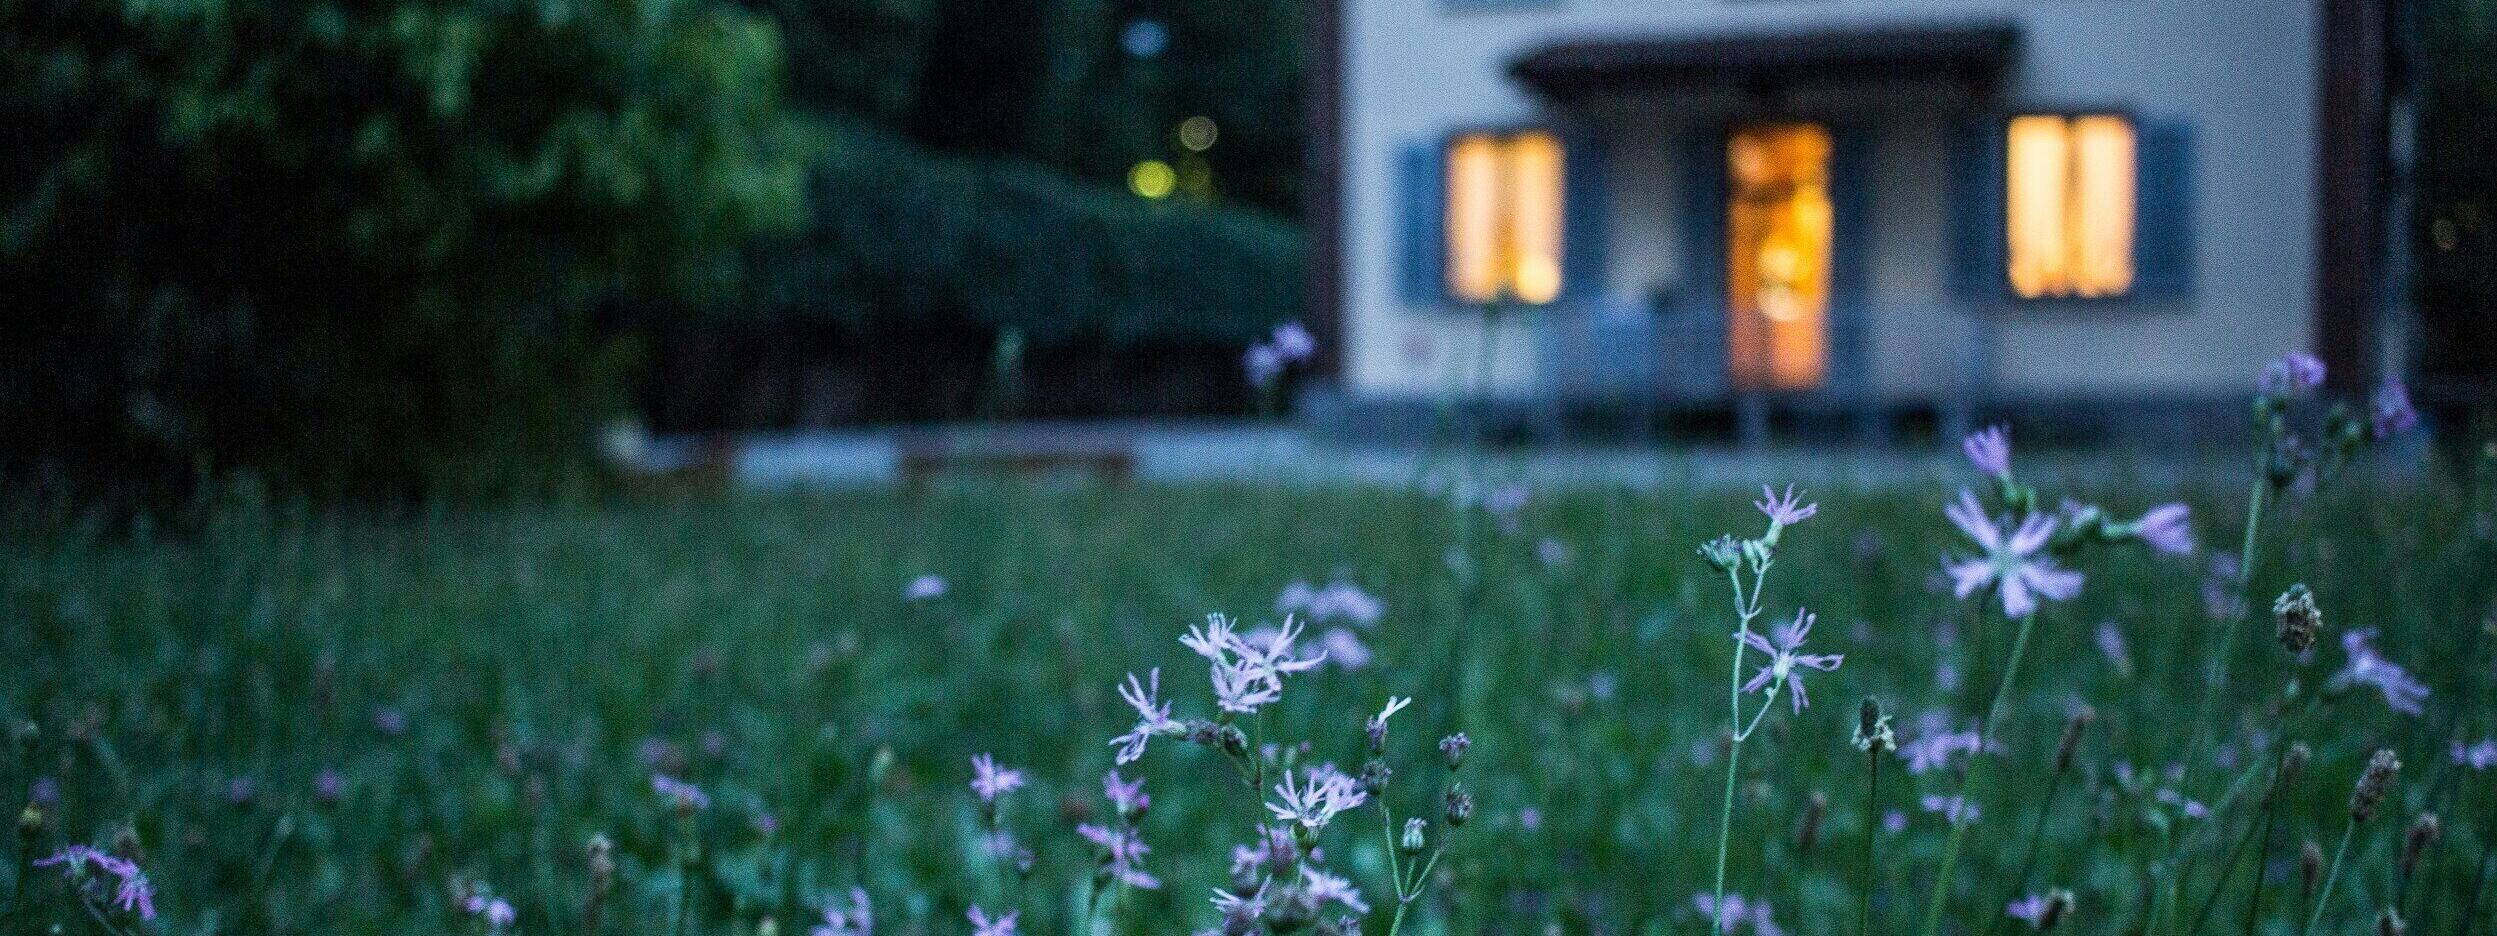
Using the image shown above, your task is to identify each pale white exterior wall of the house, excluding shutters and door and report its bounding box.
[1343,0,2317,397]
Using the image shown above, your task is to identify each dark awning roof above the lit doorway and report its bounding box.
[1508,20,2020,97]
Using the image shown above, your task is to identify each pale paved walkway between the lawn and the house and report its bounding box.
[629,422,2245,489]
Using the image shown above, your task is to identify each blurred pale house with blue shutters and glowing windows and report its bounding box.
[1308,0,2390,437]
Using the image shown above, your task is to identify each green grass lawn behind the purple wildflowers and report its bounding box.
[0,484,2497,934]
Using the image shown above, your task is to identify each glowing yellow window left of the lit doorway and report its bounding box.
[1448,130,1561,305]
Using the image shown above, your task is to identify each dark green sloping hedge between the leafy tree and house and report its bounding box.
[757,125,1301,344]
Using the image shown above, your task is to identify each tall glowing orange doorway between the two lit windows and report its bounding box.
[1725,125,1833,389]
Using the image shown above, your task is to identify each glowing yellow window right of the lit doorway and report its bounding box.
[2005,115,2132,300]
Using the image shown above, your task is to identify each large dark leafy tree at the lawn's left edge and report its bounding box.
[0,0,809,492]
